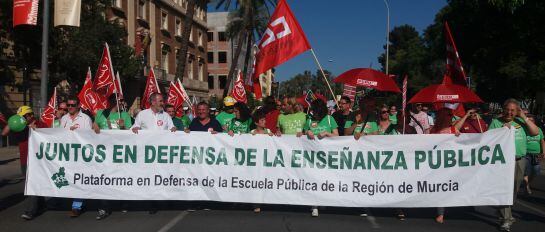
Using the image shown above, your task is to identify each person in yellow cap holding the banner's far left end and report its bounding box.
[2,106,47,220]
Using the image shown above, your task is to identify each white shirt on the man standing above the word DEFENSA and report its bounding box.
[132,109,174,130]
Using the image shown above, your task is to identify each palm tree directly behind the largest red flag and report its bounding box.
[216,0,276,97]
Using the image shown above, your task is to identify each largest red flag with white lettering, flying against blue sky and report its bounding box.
[253,0,310,80]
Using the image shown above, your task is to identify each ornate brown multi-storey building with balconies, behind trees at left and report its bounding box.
[107,0,208,100]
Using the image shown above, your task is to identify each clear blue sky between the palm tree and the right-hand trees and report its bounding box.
[209,0,447,81]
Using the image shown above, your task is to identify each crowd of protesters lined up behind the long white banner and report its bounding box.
[0,94,545,230]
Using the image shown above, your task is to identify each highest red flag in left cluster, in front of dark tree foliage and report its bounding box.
[94,43,116,99]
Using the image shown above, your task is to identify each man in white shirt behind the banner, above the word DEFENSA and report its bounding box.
[131,93,176,134]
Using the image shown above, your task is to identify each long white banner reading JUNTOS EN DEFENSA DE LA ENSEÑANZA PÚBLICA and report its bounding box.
[25,128,515,207]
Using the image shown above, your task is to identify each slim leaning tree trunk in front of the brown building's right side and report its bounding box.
[175,0,198,81]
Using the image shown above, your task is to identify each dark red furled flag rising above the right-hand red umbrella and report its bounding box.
[445,22,467,86]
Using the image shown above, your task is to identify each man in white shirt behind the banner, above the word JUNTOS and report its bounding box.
[60,97,93,217]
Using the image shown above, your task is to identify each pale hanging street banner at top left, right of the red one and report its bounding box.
[54,0,81,27]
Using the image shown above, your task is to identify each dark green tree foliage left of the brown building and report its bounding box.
[49,0,140,89]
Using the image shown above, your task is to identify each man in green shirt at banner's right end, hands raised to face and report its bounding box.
[489,98,539,231]
